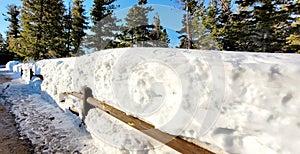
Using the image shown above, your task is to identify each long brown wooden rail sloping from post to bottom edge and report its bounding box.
[87,97,213,154]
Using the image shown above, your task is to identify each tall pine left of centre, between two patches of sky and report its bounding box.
[85,0,120,51]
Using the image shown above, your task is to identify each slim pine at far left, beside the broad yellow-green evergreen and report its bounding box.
[6,5,20,56]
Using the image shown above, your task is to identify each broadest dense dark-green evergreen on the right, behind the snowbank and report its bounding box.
[227,0,290,52]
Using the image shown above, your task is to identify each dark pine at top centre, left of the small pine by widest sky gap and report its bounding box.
[123,1,153,47]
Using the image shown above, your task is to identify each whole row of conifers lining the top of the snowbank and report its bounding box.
[0,0,300,61]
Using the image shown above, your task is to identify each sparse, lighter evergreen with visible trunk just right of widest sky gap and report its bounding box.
[178,1,217,50]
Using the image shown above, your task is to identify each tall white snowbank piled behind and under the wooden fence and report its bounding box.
[29,48,300,154]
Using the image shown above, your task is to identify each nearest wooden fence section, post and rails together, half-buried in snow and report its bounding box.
[63,87,213,154]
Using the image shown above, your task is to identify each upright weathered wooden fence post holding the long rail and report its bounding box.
[82,86,94,121]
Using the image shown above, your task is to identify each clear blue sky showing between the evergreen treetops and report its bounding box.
[0,0,192,46]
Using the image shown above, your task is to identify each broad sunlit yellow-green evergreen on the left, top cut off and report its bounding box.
[18,0,69,59]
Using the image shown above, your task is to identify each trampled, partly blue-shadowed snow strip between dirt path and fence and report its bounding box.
[0,69,101,153]
